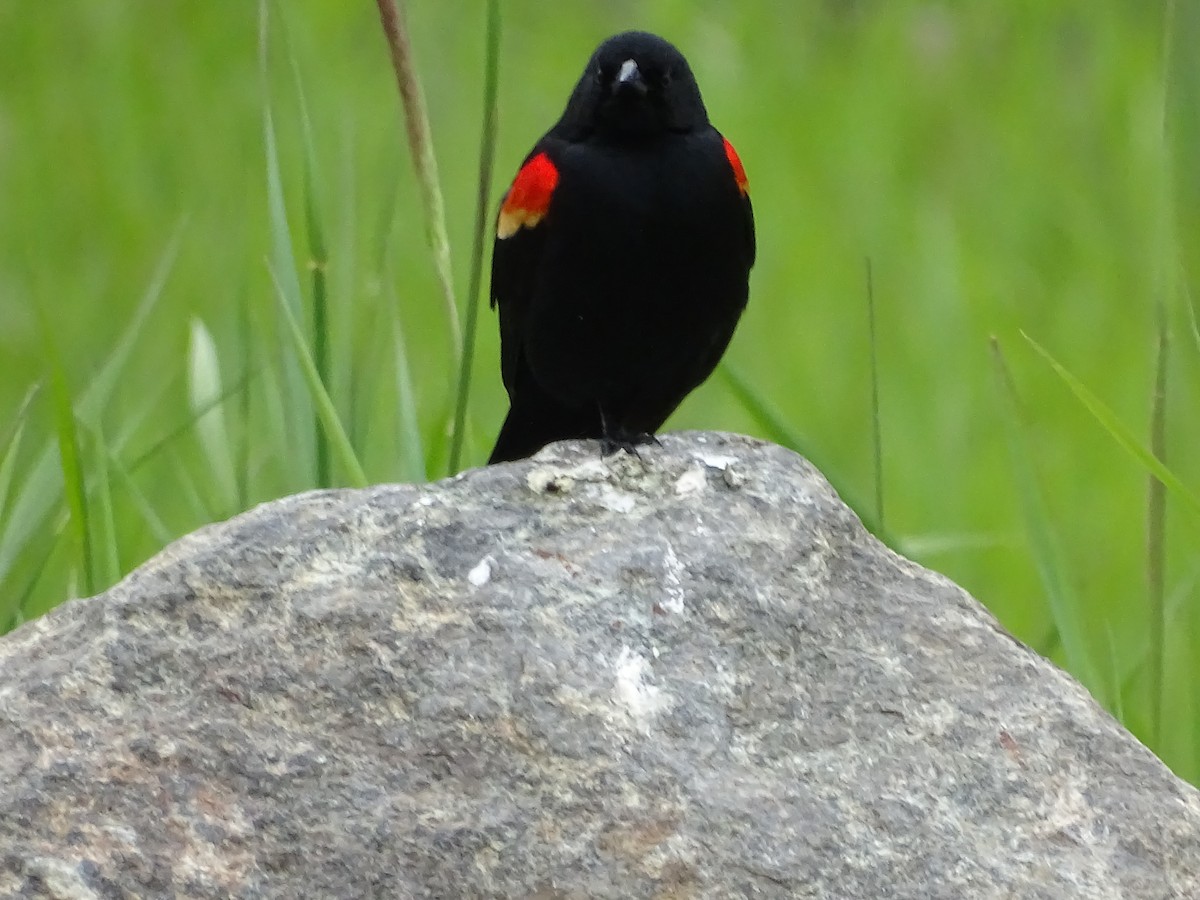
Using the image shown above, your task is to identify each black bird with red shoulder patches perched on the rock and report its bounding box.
[488,31,755,462]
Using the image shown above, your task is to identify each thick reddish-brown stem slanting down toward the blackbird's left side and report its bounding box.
[376,0,463,361]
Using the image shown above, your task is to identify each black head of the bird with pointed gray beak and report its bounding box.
[562,31,708,138]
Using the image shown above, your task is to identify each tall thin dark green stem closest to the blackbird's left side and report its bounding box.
[449,0,500,475]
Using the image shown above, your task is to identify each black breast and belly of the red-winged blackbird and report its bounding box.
[526,136,748,405]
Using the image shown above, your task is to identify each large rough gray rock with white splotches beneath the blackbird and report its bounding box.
[0,434,1200,900]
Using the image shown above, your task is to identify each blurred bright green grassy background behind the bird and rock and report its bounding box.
[0,0,1200,780]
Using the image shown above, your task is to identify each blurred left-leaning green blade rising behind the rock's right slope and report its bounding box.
[991,337,1109,706]
